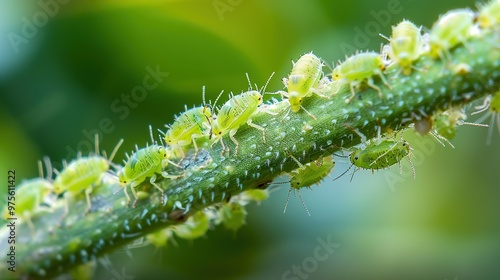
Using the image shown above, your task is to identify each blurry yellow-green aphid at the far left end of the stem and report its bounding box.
[3,160,52,234]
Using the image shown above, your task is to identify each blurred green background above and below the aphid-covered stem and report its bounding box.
[0,0,500,280]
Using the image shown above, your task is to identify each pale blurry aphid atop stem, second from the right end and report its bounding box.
[429,9,474,58]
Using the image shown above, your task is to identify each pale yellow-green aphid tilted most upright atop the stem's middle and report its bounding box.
[279,52,328,119]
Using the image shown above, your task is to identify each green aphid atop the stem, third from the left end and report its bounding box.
[118,126,182,207]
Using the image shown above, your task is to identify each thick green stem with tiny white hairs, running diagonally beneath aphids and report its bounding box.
[0,25,500,278]
